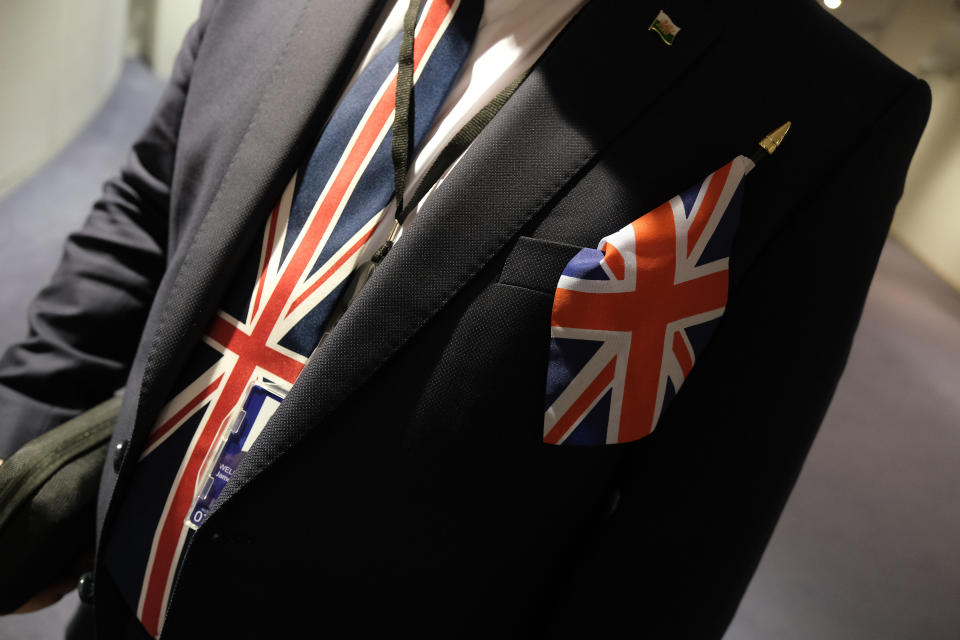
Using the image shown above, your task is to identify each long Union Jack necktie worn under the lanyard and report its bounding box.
[105,0,483,637]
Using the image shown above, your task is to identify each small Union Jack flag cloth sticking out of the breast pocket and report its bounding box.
[543,156,753,445]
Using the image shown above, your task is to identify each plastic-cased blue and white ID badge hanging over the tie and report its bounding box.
[185,382,286,529]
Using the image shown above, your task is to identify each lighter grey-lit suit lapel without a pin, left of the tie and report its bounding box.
[121,0,384,476]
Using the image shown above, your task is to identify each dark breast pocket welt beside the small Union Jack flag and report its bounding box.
[498,236,581,297]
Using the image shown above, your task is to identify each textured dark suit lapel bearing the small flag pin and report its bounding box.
[219,0,718,503]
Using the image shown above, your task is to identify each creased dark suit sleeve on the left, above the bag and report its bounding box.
[0,0,221,459]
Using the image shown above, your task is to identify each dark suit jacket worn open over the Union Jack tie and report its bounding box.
[0,0,930,638]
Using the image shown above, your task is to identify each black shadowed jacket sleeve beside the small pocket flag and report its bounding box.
[545,80,930,638]
